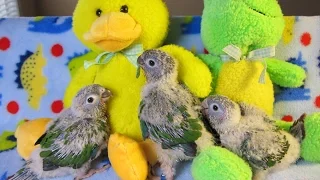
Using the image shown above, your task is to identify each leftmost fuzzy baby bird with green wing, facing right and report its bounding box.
[11,85,111,180]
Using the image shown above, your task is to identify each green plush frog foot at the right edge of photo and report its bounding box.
[301,113,320,163]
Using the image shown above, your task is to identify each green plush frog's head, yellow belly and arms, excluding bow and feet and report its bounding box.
[200,0,305,115]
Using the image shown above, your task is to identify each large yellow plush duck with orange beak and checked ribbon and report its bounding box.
[16,0,212,179]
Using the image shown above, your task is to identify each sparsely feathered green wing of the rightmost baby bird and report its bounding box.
[240,132,290,169]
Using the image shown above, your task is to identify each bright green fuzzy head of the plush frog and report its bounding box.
[201,0,284,55]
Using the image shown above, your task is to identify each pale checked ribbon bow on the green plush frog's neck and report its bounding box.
[220,45,276,84]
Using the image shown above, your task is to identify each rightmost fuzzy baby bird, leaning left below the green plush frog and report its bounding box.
[202,95,300,180]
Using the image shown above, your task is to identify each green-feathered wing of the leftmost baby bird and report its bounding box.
[40,116,103,170]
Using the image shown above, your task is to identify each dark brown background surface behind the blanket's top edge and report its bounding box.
[19,0,320,16]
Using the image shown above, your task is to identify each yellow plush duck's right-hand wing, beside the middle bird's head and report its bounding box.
[159,45,212,98]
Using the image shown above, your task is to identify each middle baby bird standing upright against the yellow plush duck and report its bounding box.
[138,50,213,180]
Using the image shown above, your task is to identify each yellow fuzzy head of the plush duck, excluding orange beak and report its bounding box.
[73,0,169,53]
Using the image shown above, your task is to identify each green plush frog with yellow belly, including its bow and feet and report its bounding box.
[192,0,320,180]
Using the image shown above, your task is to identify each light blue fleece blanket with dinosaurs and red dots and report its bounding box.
[0,17,320,180]
